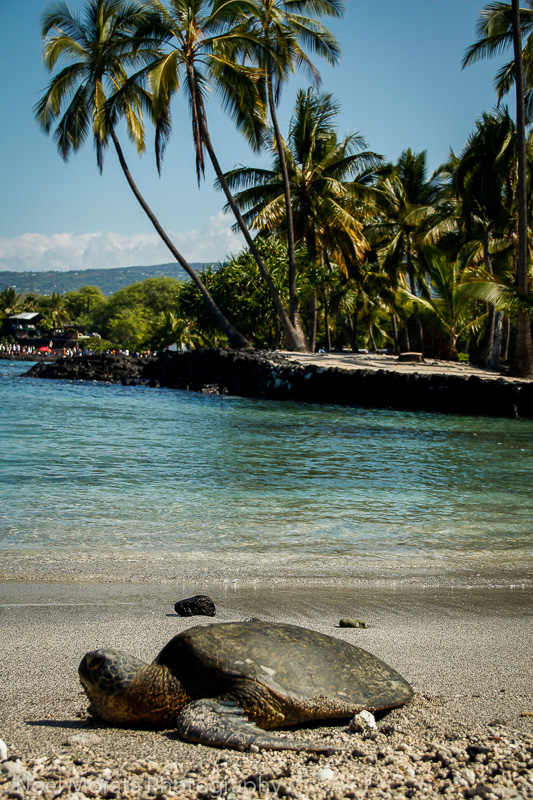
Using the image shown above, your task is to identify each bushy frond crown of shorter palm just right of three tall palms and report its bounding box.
[222,89,380,346]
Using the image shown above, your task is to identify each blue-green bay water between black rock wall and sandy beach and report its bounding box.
[0,361,533,583]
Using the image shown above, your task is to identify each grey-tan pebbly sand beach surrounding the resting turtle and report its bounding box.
[0,580,533,800]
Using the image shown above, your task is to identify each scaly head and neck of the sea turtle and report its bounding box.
[78,650,189,727]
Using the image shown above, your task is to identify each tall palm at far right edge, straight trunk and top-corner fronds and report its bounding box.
[463,0,533,377]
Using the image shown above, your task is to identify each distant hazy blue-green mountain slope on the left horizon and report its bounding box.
[0,262,209,294]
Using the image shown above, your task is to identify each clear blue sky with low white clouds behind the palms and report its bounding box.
[0,0,508,270]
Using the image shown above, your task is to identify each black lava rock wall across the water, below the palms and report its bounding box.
[26,350,533,418]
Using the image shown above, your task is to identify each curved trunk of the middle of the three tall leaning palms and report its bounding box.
[187,72,308,352]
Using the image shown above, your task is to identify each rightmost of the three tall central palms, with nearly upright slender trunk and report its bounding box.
[239,0,344,327]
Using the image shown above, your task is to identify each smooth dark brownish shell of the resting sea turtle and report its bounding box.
[156,621,413,720]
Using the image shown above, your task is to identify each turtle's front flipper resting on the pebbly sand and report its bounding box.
[177,697,332,753]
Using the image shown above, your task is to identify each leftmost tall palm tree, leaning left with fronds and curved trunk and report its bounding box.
[35,0,249,347]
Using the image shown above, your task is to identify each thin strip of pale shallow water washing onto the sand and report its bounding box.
[0,548,533,590]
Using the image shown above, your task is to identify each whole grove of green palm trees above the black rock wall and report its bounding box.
[35,0,533,377]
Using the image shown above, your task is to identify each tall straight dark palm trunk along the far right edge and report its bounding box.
[511,0,533,378]
